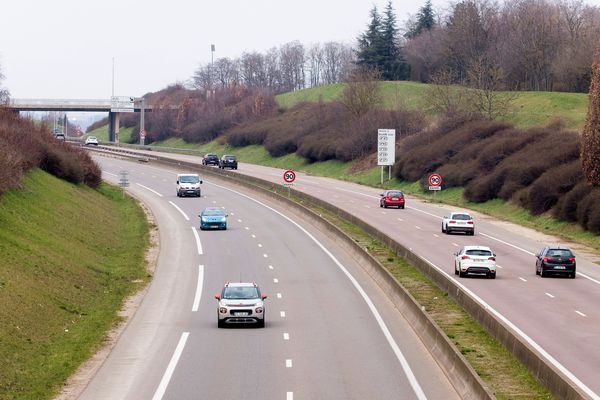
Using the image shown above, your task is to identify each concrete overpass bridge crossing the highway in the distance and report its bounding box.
[7,97,152,142]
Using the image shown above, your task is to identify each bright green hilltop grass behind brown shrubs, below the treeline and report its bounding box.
[275,81,588,131]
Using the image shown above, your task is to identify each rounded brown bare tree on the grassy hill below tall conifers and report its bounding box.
[341,69,382,115]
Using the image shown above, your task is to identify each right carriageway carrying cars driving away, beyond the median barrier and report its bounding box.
[118,151,600,399]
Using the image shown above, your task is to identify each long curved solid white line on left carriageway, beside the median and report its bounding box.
[205,183,427,400]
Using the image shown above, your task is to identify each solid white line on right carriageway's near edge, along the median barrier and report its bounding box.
[421,257,600,400]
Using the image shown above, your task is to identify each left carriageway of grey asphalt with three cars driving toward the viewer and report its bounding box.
[79,157,458,400]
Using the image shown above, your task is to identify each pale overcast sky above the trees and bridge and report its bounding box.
[0,0,600,99]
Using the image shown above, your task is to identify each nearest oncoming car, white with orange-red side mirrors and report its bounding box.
[215,282,267,328]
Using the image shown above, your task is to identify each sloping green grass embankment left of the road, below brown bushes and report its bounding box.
[0,170,149,400]
